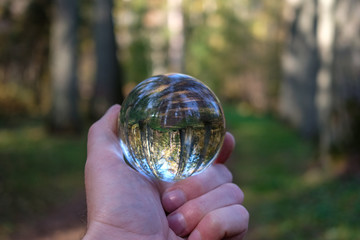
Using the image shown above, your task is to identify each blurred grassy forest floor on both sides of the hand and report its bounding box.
[0,106,360,240]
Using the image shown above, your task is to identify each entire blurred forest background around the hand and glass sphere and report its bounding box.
[0,0,360,240]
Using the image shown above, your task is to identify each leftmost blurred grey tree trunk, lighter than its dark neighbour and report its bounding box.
[50,0,80,132]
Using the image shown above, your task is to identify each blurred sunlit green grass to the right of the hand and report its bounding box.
[225,106,360,240]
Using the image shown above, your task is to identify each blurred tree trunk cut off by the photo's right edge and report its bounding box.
[330,0,360,175]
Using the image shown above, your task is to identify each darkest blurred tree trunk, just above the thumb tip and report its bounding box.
[90,0,123,118]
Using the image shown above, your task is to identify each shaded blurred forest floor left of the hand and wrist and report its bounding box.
[0,120,86,240]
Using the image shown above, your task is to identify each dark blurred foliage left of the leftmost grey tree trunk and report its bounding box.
[0,0,51,117]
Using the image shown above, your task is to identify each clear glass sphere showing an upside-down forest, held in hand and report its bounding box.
[118,74,225,182]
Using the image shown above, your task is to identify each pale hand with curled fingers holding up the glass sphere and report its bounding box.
[83,105,249,240]
